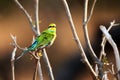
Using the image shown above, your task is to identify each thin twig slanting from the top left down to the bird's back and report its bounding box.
[14,0,38,35]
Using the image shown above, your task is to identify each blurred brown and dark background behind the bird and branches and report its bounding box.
[0,0,120,80]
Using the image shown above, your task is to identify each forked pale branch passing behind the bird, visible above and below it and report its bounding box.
[14,0,54,80]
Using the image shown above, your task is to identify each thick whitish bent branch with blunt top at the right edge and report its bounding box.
[100,25,120,80]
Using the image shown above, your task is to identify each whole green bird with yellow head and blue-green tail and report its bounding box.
[16,23,56,60]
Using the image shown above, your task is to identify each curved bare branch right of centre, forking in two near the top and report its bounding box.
[83,0,102,65]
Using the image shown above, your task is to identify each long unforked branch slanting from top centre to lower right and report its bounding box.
[62,0,98,78]
